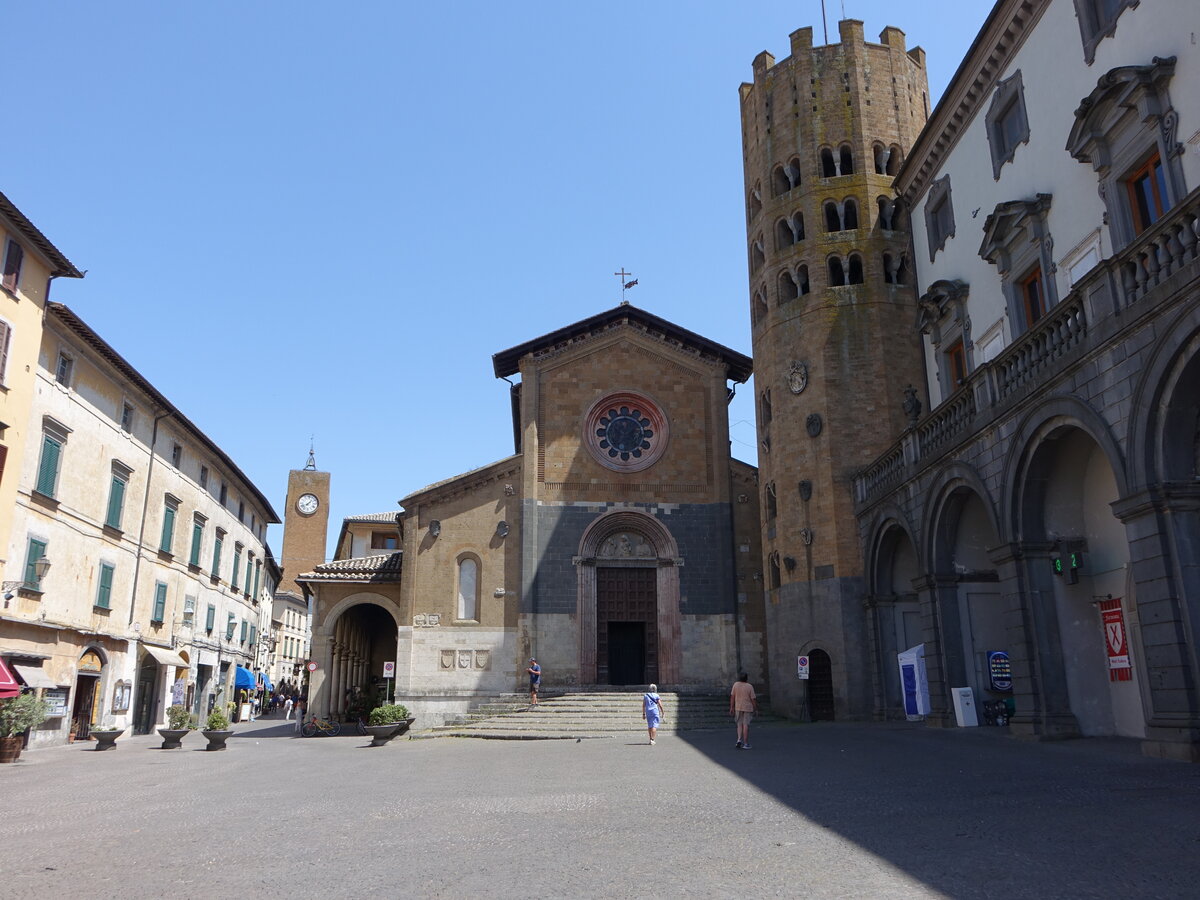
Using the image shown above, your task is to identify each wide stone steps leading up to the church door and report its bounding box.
[422,691,773,740]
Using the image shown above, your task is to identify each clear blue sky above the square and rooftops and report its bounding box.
[0,0,991,564]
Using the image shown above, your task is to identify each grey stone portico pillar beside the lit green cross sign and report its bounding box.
[988,541,1080,740]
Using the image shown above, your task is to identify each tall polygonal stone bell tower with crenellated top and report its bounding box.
[740,19,929,719]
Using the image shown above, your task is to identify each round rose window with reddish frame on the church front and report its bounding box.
[583,391,668,472]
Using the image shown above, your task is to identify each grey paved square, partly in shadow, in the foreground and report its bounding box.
[0,720,1200,900]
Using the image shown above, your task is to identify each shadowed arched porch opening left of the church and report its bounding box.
[308,592,400,718]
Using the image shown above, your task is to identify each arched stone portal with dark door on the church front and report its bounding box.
[574,510,683,685]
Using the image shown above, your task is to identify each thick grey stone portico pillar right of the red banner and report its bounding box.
[1112,482,1200,762]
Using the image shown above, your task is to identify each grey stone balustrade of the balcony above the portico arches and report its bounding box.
[854,188,1200,508]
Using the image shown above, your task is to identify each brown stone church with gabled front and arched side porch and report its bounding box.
[304,304,766,724]
